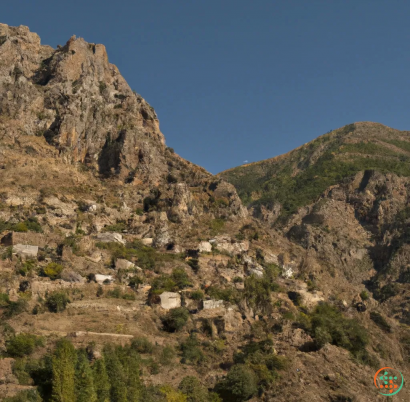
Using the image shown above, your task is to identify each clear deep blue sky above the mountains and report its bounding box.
[0,0,410,173]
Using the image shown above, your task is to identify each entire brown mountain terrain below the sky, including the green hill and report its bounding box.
[0,24,410,402]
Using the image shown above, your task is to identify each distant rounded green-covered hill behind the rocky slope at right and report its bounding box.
[218,122,410,217]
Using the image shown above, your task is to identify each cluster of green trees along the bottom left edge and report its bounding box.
[6,339,226,402]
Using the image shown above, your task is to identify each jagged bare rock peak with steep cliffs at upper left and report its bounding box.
[0,24,167,182]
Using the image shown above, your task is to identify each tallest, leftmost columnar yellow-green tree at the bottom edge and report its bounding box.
[51,339,77,402]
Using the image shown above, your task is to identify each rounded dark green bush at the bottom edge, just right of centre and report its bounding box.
[215,364,258,402]
